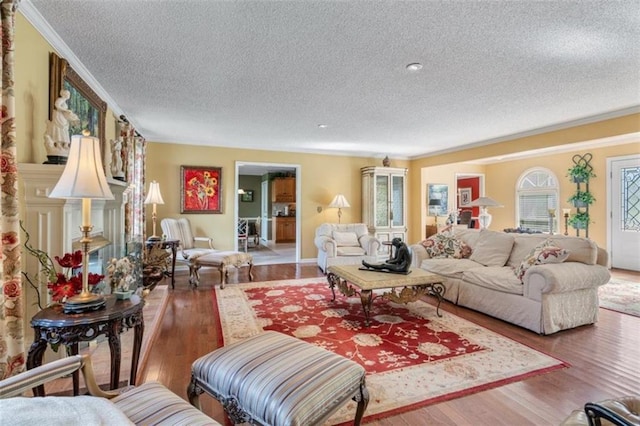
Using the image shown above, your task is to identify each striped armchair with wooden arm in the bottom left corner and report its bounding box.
[0,355,220,425]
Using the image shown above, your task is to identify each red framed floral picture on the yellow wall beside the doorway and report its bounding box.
[180,166,222,214]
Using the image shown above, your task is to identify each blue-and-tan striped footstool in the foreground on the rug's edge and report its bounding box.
[187,331,369,426]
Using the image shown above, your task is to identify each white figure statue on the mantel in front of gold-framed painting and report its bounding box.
[44,89,80,164]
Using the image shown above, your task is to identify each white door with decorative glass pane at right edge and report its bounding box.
[609,156,640,271]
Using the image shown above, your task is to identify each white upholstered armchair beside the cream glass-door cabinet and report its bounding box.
[314,223,380,274]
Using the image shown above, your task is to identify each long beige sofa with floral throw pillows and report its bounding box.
[411,228,610,334]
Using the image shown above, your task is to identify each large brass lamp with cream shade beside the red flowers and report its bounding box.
[49,130,114,313]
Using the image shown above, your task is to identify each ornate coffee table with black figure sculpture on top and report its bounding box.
[327,265,446,327]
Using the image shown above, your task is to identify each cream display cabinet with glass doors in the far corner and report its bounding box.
[360,166,407,255]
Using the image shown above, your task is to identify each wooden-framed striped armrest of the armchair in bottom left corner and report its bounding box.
[0,355,118,399]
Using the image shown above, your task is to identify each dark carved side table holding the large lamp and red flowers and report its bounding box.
[27,296,144,396]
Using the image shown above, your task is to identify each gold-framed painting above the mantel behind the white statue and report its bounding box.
[49,52,107,158]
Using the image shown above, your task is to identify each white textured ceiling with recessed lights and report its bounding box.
[19,0,640,158]
